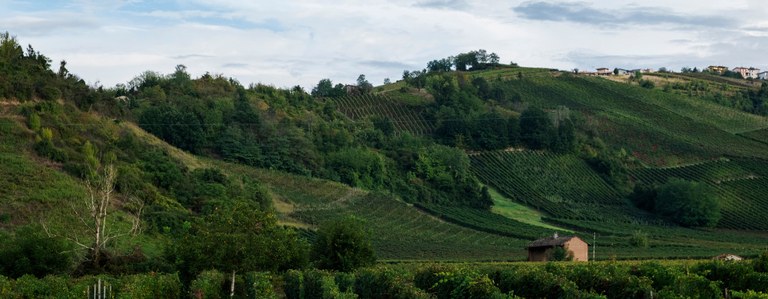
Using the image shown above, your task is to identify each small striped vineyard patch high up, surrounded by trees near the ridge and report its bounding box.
[334,94,435,135]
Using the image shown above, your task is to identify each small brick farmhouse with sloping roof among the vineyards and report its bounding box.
[527,233,589,262]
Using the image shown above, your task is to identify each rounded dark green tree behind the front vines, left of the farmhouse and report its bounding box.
[311,216,376,272]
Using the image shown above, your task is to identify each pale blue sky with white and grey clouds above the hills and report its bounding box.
[0,0,768,90]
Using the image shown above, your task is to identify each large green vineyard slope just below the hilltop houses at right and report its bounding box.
[505,75,768,166]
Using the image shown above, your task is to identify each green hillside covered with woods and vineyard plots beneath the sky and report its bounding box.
[0,36,768,294]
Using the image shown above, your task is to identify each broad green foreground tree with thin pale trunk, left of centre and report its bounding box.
[177,200,307,297]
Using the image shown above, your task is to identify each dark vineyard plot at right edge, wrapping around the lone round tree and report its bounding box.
[632,159,768,230]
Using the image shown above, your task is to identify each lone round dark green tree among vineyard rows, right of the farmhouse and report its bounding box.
[654,178,720,227]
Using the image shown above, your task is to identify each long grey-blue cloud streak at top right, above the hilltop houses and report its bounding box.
[512,1,735,28]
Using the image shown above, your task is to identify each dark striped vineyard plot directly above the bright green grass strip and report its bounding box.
[470,151,656,222]
